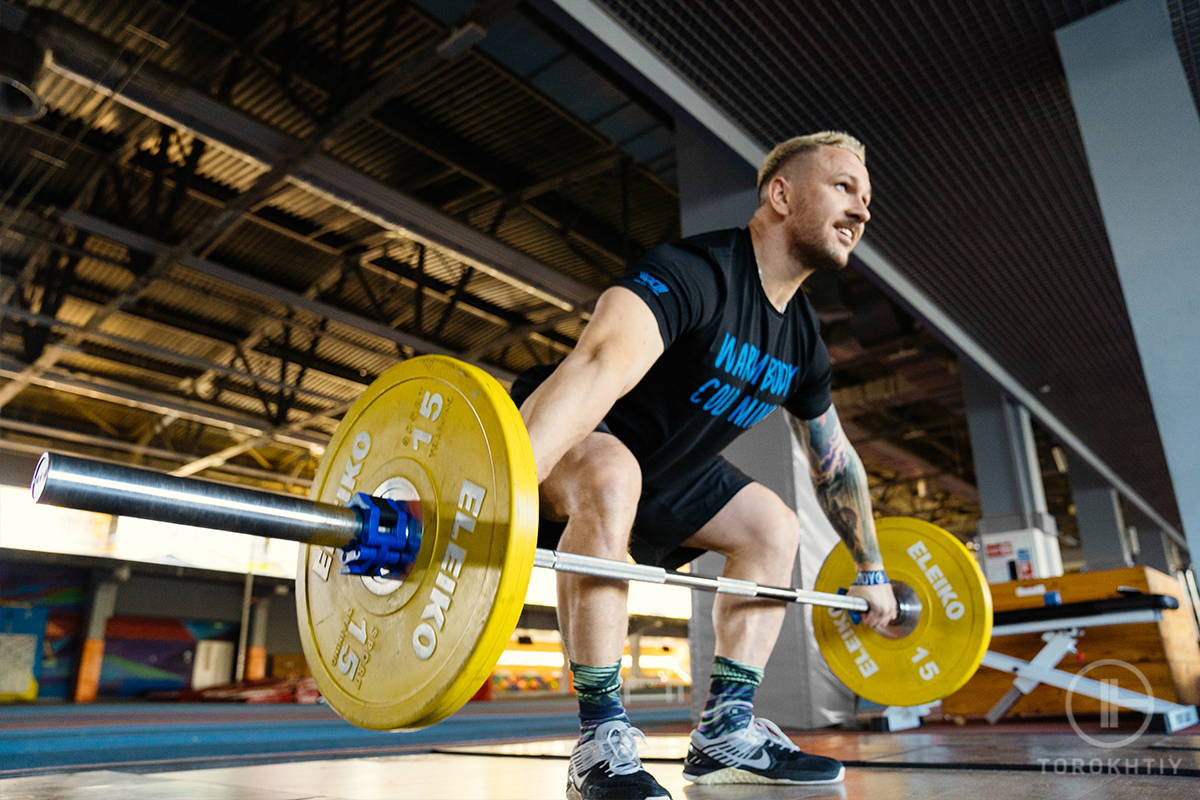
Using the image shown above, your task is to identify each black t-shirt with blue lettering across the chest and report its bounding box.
[520,229,832,489]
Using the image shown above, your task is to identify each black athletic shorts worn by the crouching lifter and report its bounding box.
[512,371,754,570]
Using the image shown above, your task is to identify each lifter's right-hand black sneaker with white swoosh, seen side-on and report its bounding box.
[683,717,846,783]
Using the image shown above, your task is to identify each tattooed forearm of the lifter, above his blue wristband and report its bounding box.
[803,405,882,564]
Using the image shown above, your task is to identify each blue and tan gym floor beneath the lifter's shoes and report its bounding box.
[0,700,1200,800]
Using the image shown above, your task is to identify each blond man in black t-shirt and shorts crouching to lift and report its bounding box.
[512,132,896,799]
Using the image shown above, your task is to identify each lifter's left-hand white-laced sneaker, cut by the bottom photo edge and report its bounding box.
[566,720,671,800]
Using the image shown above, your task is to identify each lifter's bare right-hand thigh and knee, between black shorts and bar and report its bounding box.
[683,482,800,571]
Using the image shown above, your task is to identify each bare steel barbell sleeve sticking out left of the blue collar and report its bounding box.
[30,452,361,547]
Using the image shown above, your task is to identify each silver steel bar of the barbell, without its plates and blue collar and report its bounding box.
[30,452,869,613]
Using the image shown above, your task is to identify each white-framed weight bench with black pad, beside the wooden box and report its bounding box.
[983,593,1198,733]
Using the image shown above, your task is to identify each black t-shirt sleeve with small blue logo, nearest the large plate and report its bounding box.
[613,245,722,349]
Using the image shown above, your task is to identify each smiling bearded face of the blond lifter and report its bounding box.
[782,146,871,271]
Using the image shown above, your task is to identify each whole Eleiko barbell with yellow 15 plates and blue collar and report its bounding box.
[31,356,992,730]
